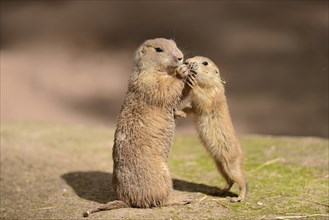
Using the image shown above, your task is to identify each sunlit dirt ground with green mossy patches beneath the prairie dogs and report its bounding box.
[0,122,329,219]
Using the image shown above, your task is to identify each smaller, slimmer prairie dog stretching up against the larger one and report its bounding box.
[175,56,248,202]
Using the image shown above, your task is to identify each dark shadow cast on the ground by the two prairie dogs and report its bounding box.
[61,171,237,204]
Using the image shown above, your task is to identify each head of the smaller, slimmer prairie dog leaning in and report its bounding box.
[185,56,225,87]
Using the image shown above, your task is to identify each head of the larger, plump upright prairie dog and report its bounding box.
[135,38,184,72]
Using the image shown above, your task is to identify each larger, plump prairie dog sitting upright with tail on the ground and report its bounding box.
[84,38,190,216]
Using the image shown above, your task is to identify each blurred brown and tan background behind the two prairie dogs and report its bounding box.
[1,1,328,137]
